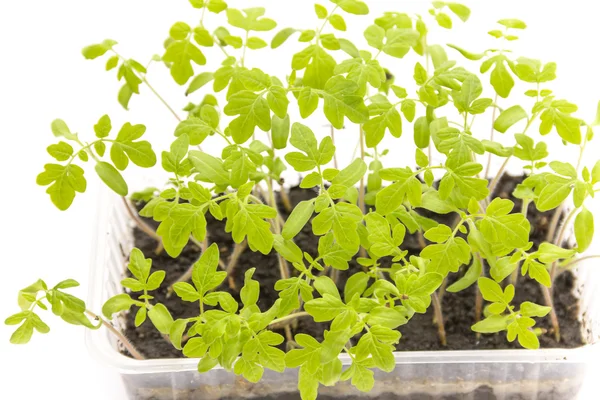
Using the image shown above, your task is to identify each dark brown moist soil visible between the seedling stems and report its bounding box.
[125,175,583,359]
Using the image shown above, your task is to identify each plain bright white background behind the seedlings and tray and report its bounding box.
[0,0,600,399]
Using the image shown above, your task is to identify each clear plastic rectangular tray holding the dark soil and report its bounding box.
[86,192,600,400]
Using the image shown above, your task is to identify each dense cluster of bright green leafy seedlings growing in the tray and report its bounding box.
[6,0,600,399]
